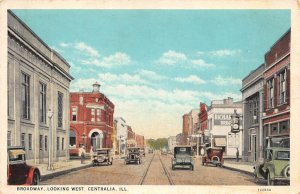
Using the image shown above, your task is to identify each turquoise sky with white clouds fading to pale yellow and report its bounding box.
[13,10,291,138]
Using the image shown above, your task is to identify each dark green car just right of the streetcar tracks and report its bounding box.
[172,145,194,170]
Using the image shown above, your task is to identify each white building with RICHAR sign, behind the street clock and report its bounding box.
[205,98,243,157]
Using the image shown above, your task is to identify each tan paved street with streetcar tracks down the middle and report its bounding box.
[41,152,256,185]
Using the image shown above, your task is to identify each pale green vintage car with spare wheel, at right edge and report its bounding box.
[253,138,290,185]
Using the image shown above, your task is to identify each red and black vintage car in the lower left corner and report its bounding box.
[7,146,41,185]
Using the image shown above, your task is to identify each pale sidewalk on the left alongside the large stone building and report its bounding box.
[29,159,92,181]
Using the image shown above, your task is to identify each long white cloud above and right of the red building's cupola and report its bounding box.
[81,52,131,68]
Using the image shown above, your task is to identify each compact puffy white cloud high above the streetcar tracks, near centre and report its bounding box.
[157,50,187,65]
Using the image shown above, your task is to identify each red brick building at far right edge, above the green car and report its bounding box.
[263,30,291,144]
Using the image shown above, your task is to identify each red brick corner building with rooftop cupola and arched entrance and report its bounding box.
[70,82,114,155]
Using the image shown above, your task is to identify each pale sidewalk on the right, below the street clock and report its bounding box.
[223,159,254,175]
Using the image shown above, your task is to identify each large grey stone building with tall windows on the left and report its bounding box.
[7,11,73,164]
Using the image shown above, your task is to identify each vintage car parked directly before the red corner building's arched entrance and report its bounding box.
[92,148,113,166]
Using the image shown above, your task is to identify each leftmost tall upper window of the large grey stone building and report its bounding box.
[21,73,30,120]
